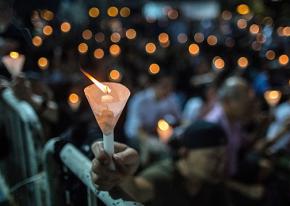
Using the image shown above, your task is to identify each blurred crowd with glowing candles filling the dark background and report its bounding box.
[0,0,290,206]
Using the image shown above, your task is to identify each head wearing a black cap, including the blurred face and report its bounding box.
[171,121,227,182]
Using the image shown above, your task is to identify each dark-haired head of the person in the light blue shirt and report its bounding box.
[151,73,174,100]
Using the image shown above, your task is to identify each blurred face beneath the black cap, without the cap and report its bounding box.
[185,146,226,183]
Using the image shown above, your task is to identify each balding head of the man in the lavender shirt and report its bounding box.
[218,77,254,120]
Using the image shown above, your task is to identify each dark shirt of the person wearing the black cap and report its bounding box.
[140,159,229,206]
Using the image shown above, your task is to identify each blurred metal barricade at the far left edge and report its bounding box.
[0,88,42,206]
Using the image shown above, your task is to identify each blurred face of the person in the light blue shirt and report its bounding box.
[155,77,173,99]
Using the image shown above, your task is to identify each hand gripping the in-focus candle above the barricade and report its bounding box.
[91,142,139,191]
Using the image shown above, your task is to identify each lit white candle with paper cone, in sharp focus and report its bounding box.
[82,71,130,169]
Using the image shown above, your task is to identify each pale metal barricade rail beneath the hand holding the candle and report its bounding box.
[44,138,142,206]
